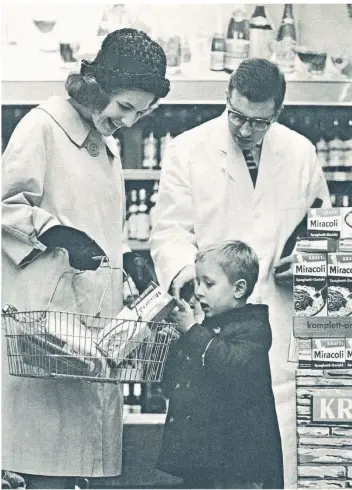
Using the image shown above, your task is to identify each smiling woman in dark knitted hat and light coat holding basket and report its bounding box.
[2,29,169,488]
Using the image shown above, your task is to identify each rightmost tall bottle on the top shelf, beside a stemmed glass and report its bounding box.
[275,3,297,73]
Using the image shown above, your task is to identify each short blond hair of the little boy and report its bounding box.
[196,240,259,298]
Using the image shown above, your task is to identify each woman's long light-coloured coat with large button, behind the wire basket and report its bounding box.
[2,97,125,477]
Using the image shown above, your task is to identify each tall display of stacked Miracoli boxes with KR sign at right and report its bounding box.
[293,208,352,488]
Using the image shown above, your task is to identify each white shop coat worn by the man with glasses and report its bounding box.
[151,113,330,488]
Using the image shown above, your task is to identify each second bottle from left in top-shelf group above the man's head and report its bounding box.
[225,5,249,73]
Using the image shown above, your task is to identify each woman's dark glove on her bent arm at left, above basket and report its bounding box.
[38,225,105,271]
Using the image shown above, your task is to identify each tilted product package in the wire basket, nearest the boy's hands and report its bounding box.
[97,282,176,366]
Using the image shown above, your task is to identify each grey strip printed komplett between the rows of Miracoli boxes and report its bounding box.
[293,316,352,338]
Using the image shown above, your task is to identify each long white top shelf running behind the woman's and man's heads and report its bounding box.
[1,47,352,106]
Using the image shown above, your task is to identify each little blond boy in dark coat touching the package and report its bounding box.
[157,241,283,488]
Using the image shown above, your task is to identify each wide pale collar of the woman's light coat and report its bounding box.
[38,96,119,157]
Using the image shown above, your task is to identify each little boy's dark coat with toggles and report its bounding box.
[157,304,283,488]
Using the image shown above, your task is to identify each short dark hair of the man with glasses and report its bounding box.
[228,58,286,112]
